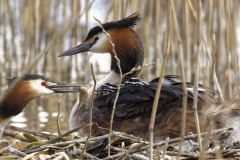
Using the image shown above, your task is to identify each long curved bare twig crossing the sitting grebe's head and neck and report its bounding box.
[94,17,123,156]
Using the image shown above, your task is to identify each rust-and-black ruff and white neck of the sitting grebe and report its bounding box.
[88,28,144,95]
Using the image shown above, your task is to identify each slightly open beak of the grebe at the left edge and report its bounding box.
[46,83,85,93]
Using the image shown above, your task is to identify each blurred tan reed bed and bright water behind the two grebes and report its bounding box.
[0,0,240,149]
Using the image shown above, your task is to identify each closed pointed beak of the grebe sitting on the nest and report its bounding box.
[58,43,91,57]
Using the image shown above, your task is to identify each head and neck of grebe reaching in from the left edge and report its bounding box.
[0,74,82,139]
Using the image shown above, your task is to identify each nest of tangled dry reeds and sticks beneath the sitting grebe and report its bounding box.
[0,127,240,160]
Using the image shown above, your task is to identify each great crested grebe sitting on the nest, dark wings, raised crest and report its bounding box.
[59,13,240,144]
